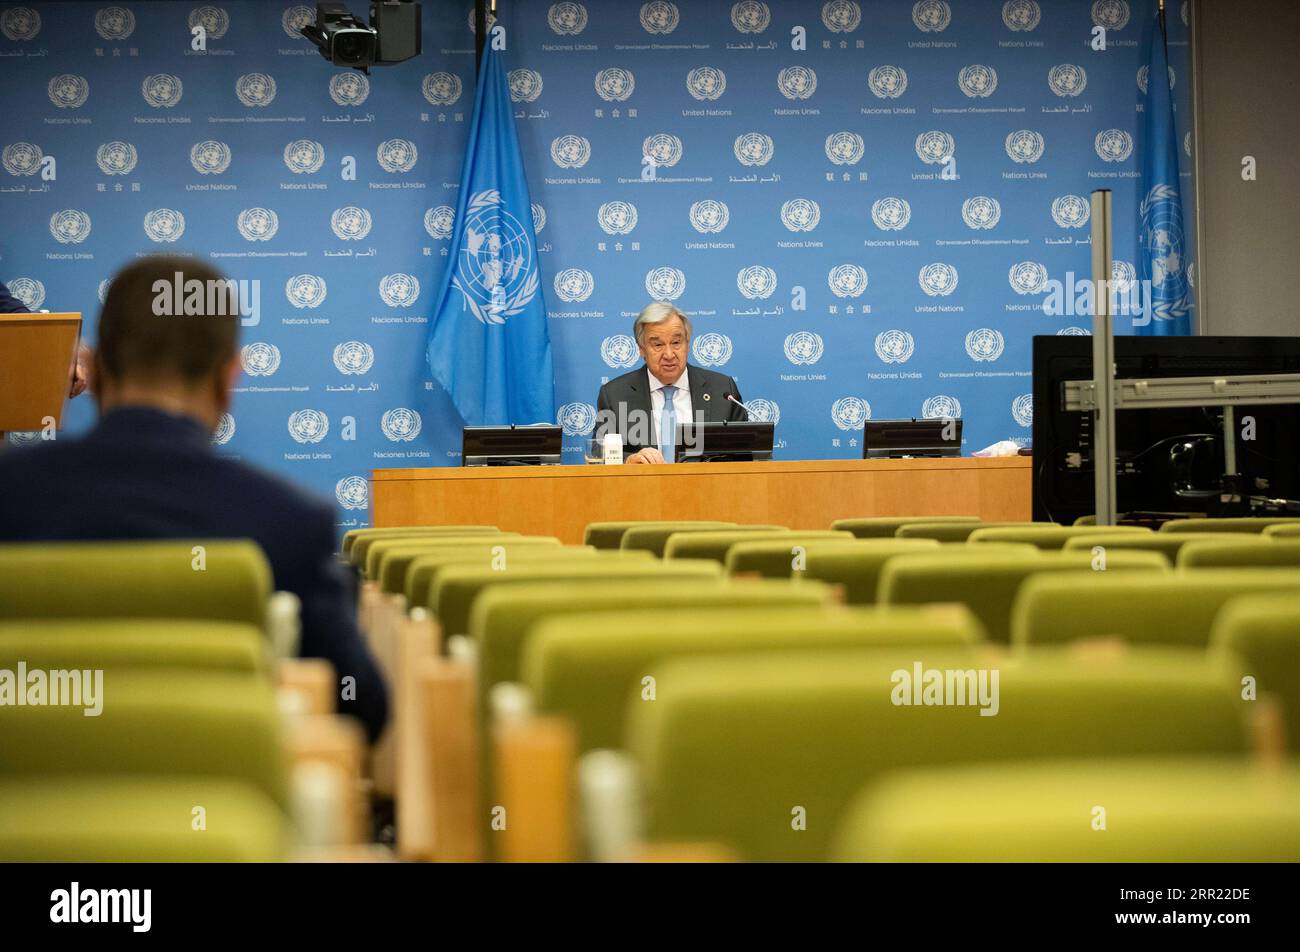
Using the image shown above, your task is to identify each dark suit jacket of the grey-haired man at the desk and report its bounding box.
[592,364,746,456]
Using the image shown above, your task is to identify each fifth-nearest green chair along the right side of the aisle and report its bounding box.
[428,558,723,637]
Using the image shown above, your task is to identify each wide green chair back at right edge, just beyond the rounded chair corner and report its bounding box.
[1011,568,1300,648]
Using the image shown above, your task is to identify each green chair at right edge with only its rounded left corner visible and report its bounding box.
[1210,592,1300,749]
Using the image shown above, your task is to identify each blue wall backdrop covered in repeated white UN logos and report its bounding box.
[0,0,1195,527]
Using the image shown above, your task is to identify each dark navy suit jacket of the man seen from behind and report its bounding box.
[0,407,387,740]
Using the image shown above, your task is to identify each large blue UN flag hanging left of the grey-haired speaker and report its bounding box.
[428,38,555,425]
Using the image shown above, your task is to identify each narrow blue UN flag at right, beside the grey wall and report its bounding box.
[1134,3,1192,336]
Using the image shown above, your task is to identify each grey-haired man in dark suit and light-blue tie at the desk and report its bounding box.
[595,300,748,463]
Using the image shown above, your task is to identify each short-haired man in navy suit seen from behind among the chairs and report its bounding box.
[0,256,387,740]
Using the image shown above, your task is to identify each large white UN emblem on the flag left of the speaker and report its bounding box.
[451,189,541,324]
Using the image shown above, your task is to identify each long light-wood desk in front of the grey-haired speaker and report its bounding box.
[371,456,1031,542]
